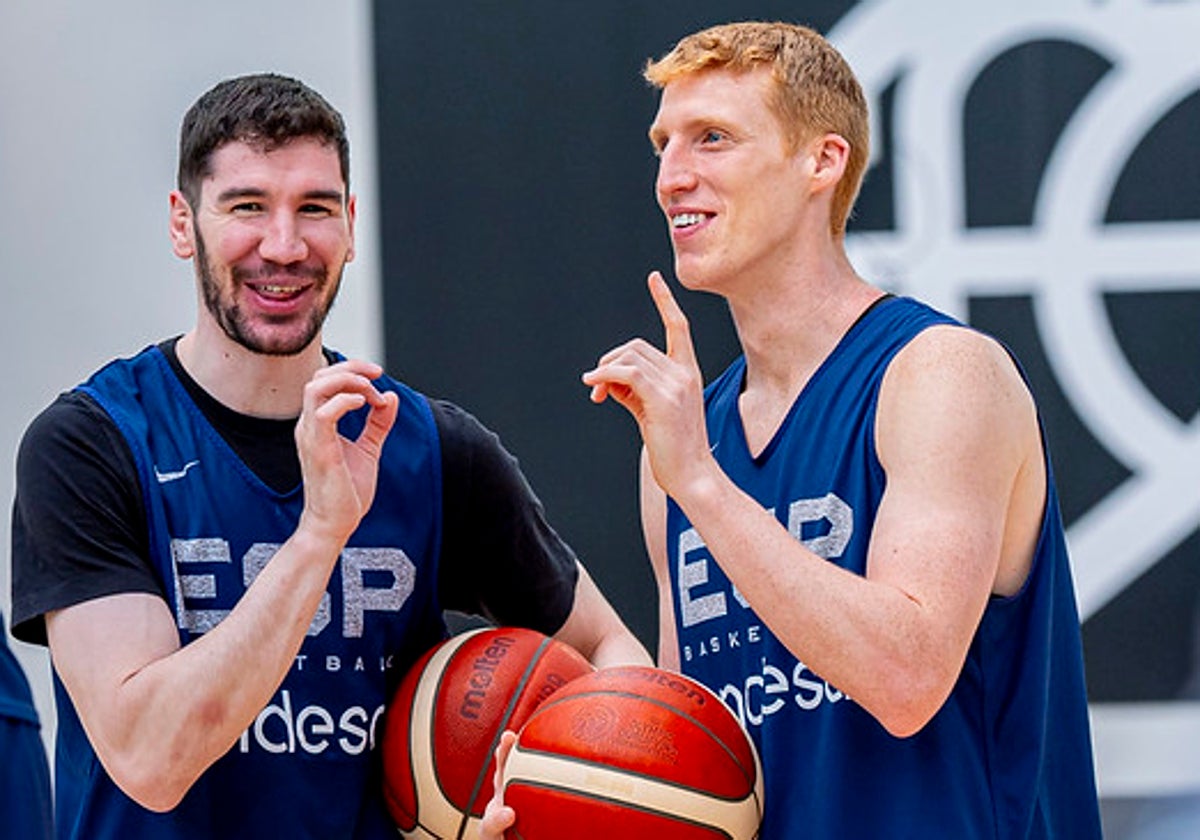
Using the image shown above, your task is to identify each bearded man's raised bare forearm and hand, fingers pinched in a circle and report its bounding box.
[47,361,397,810]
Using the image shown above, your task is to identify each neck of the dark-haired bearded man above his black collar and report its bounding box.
[175,326,325,419]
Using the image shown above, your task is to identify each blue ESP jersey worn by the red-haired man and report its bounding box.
[667,298,1100,840]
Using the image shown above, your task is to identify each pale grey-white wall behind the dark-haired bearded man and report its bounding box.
[0,0,382,758]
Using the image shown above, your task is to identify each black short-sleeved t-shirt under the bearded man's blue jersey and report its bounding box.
[12,340,577,644]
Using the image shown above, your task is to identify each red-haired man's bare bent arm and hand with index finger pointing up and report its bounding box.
[584,278,1044,736]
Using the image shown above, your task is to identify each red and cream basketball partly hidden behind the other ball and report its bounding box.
[382,628,592,840]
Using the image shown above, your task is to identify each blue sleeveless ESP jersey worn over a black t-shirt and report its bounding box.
[55,347,445,840]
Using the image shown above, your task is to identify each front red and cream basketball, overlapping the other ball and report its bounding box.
[504,666,762,840]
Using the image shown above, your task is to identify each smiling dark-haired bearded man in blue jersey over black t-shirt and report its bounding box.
[12,74,649,840]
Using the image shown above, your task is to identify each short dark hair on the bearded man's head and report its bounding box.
[178,73,350,206]
